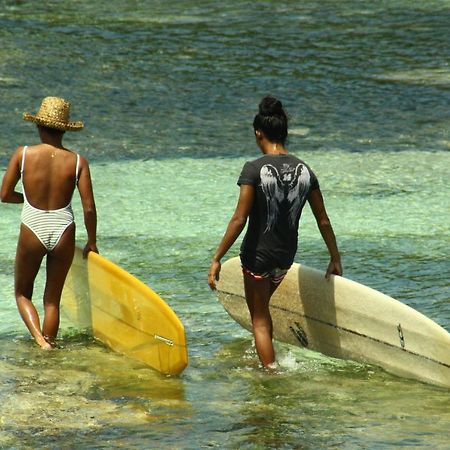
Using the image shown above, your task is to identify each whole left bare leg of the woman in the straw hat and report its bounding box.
[14,225,51,350]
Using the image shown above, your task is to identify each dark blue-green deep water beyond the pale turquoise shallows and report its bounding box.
[0,0,449,161]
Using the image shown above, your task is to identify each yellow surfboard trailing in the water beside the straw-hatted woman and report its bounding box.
[61,247,188,375]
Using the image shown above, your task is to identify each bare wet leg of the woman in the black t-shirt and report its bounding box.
[244,274,276,367]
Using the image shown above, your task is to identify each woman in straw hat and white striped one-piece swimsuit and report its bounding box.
[1,97,98,349]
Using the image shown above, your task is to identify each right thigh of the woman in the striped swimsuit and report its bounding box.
[45,224,75,300]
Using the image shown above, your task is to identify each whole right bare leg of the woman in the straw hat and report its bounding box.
[42,224,75,342]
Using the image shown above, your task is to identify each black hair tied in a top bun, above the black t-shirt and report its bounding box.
[253,96,288,145]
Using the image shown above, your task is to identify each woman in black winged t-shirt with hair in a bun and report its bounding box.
[208,97,342,367]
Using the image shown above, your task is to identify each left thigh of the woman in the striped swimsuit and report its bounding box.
[14,225,46,299]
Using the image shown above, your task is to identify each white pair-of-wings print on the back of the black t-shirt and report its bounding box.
[260,164,311,233]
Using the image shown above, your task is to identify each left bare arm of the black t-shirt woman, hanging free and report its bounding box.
[208,184,255,289]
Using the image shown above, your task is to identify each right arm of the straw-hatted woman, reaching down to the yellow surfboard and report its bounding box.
[78,158,98,258]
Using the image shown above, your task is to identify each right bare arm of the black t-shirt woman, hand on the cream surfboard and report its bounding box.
[308,189,342,279]
